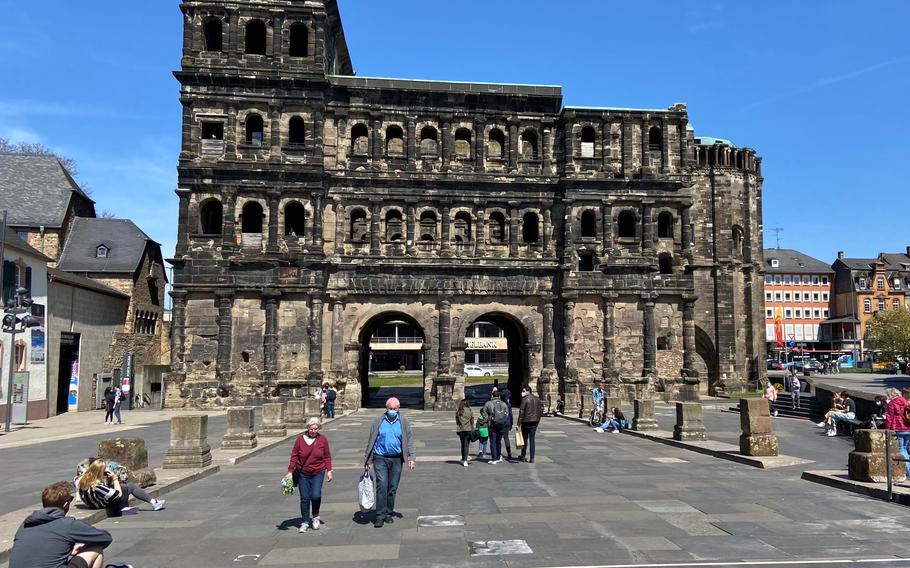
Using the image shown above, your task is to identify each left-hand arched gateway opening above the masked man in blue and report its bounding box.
[359,313,426,409]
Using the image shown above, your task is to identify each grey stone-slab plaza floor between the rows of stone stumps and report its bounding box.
[7,411,910,568]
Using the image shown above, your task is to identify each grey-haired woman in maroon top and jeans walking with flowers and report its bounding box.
[284,418,332,533]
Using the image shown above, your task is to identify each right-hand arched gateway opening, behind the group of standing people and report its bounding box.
[464,314,530,406]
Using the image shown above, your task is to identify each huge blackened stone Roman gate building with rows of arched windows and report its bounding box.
[166,0,764,412]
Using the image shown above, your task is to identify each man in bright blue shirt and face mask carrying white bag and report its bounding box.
[363,397,417,529]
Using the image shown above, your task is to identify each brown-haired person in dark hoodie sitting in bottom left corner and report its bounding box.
[9,481,132,568]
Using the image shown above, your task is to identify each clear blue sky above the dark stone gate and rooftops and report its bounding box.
[0,0,910,262]
